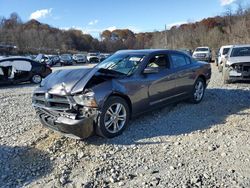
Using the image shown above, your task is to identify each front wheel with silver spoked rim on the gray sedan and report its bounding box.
[96,97,130,138]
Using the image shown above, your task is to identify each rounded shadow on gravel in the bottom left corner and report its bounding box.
[0,145,53,187]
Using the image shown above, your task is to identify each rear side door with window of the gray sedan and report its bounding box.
[170,52,197,96]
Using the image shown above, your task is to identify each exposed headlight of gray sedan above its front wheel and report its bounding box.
[73,91,97,107]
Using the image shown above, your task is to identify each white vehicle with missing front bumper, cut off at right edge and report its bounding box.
[222,44,250,83]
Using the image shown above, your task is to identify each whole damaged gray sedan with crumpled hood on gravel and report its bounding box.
[33,50,211,138]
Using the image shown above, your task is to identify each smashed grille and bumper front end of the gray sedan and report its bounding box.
[32,92,99,139]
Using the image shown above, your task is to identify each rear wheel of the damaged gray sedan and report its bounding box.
[190,78,206,104]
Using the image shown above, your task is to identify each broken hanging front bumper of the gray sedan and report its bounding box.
[36,108,94,139]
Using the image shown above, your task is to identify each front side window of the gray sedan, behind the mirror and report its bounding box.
[147,55,170,71]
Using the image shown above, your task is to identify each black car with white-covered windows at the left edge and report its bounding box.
[0,57,52,84]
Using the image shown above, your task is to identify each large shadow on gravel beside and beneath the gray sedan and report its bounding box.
[87,89,250,145]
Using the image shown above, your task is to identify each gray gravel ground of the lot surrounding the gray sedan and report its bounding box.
[0,66,250,187]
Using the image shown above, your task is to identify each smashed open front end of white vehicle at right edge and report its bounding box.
[224,62,250,82]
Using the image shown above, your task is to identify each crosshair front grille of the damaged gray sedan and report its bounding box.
[33,93,71,111]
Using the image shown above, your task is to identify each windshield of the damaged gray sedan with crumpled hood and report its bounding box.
[97,54,144,75]
